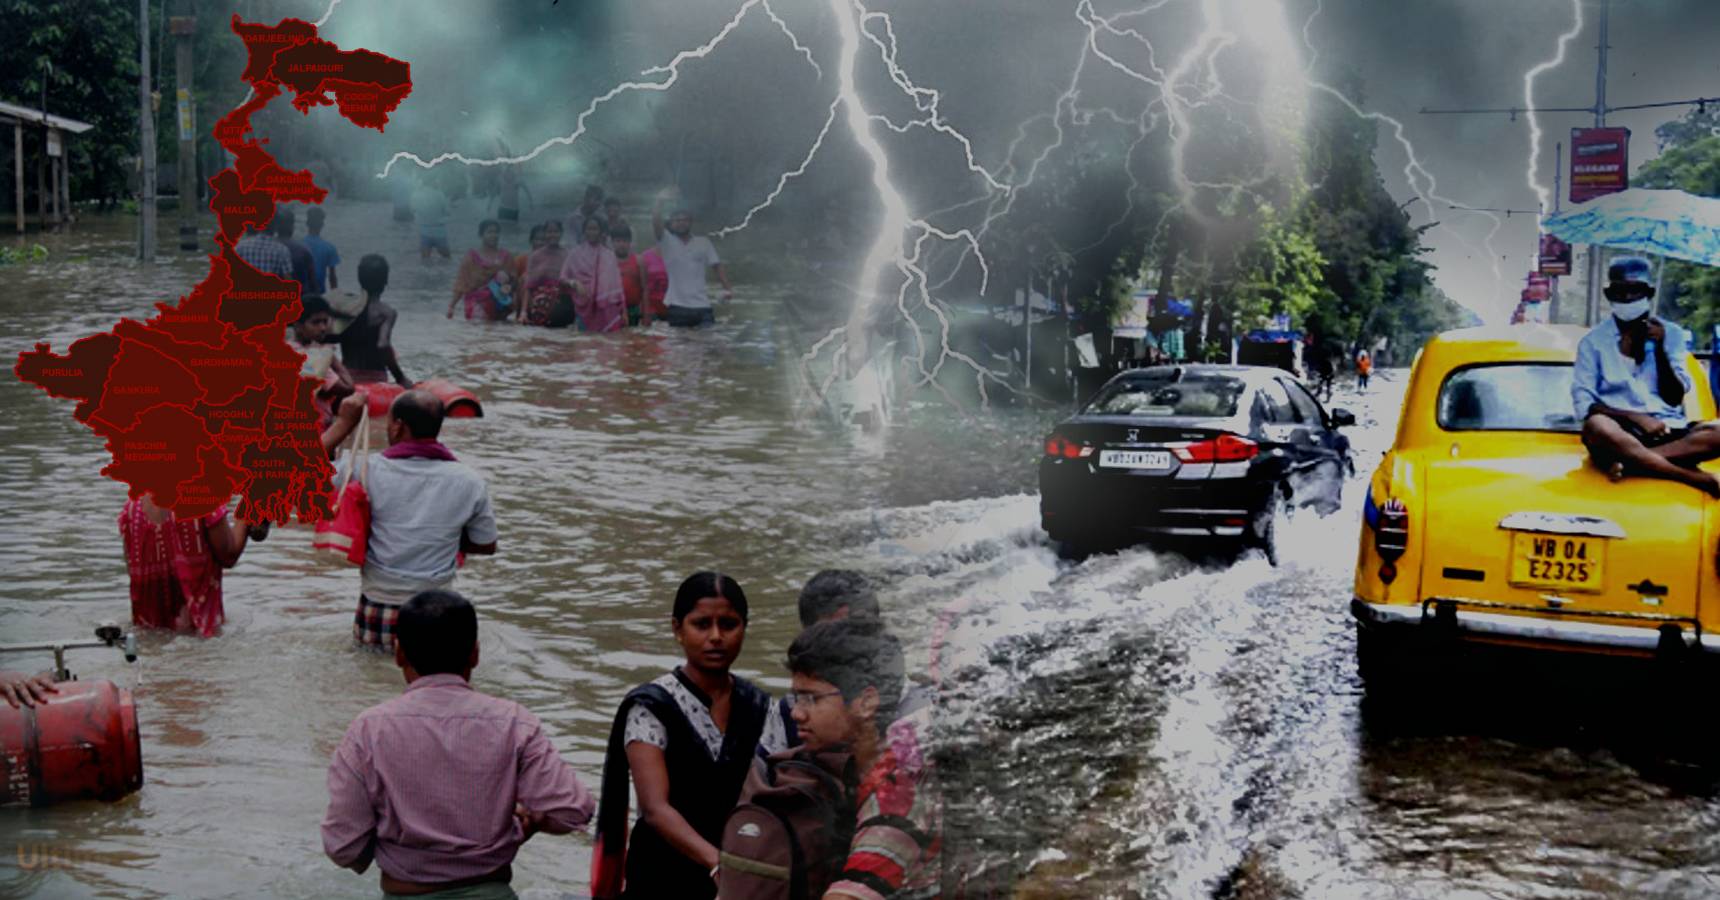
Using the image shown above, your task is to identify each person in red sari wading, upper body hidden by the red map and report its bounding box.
[119,494,258,637]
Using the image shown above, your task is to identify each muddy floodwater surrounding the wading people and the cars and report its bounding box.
[0,203,1720,898]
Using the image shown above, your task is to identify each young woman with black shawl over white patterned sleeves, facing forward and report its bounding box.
[592,571,786,900]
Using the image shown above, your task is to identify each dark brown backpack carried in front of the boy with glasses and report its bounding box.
[717,747,860,900]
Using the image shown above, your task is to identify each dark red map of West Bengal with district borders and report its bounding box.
[15,15,413,521]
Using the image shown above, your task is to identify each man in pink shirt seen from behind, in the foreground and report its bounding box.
[322,590,597,900]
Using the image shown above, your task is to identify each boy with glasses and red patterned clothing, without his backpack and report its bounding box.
[788,618,941,900]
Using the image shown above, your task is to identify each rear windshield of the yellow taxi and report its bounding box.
[1440,363,1582,432]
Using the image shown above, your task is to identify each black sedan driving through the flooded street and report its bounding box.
[1039,365,1355,564]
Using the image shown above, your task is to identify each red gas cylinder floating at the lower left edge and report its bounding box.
[0,681,143,807]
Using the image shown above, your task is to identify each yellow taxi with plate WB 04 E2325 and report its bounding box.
[1350,325,1720,687]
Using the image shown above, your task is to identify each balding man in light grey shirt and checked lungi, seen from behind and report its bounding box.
[346,391,497,650]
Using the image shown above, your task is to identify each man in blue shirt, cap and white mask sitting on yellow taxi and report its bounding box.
[1570,256,1720,497]
